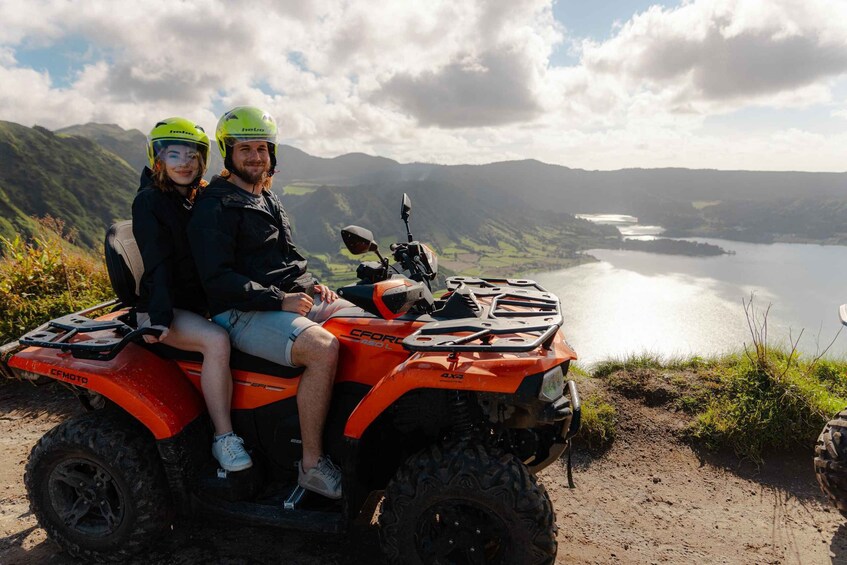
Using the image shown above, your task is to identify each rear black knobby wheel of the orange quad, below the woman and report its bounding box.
[24,410,173,561]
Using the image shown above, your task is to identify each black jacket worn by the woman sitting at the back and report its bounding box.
[132,167,206,327]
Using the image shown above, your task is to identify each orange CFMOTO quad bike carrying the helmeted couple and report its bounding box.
[0,195,580,564]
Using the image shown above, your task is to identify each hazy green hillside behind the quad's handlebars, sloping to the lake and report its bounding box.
[281,181,619,285]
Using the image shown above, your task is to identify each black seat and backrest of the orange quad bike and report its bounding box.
[105,220,303,379]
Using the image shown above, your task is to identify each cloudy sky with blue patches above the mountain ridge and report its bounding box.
[0,0,847,171]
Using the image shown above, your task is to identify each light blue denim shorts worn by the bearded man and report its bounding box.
[212,297,353,367]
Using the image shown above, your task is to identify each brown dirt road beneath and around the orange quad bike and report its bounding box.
[0,383,847,565]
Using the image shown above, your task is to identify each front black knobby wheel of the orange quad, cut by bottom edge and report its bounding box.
[379,444,557,565]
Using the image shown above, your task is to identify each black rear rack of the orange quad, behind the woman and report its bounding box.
[18,301,161,361]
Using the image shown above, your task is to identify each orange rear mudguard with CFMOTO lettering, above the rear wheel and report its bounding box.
[8,343,206,440]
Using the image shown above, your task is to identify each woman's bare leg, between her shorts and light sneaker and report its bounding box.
[163,308,232,435]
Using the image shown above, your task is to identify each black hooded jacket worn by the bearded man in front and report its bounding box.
[188,177,306,316]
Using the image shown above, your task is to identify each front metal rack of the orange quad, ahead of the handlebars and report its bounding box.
[403,277,562,353]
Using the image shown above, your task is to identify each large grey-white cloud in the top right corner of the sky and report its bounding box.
[583,0,847,111]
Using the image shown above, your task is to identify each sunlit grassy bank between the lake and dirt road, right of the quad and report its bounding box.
[593,341,847,462]
